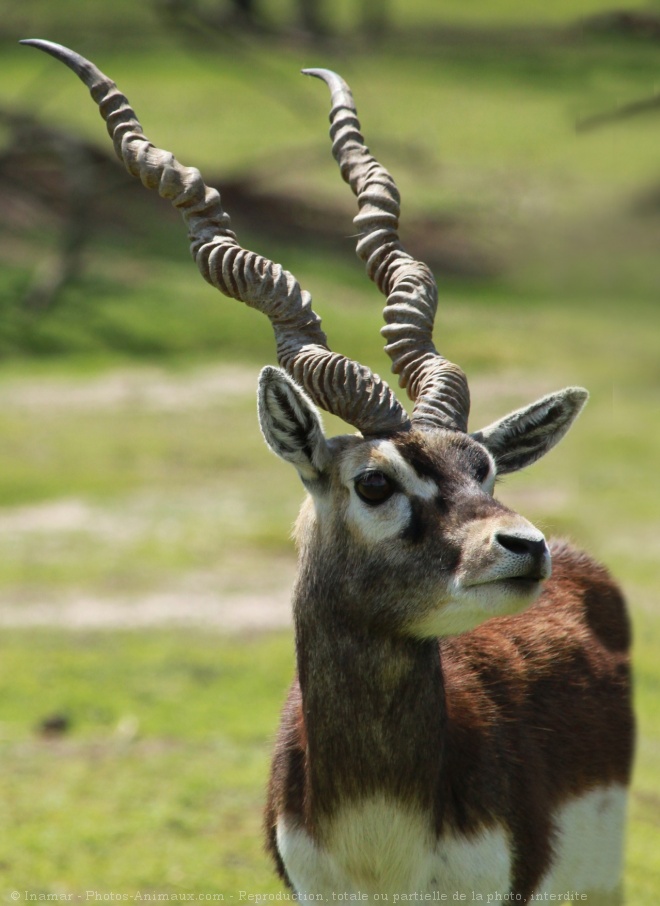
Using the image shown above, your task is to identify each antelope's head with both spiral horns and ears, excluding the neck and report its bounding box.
[24,40,587,638]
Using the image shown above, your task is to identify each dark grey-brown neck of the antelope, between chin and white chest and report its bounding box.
[295,580,446,828]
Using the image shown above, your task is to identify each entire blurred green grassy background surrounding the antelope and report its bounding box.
[0,0,660,906]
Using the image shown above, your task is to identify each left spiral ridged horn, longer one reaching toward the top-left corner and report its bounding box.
[21,39,410,435]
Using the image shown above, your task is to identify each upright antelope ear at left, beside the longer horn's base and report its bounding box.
[258,366,330,481]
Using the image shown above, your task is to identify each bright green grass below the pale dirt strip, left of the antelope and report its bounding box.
[0,632,292,899]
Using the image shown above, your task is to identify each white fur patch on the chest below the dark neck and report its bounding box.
[277,797,510,902]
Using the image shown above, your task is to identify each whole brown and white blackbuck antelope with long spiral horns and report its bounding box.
[26,40,633,904]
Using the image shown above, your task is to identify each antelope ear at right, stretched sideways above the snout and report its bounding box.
[472,387,589,475]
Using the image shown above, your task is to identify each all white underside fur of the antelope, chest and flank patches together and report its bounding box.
[277,786,626,906]
